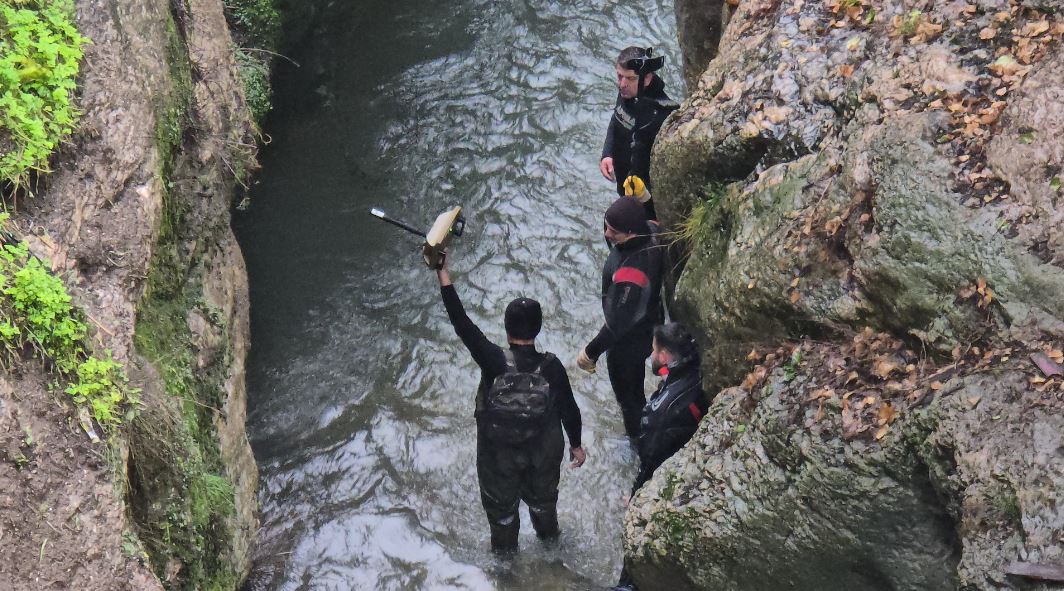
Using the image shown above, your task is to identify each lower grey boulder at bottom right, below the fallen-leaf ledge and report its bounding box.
[625,359,1064,591]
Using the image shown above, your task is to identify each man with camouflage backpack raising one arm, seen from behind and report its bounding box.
[436,254,586,557]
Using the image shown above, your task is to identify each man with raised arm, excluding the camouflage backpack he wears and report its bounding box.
[436,256,586,556]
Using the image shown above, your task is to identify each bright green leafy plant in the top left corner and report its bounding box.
[0,0,87,188]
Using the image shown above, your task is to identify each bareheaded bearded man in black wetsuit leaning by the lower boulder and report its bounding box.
[612,323,709,591]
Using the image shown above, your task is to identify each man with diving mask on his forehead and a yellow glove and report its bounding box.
[599,47,680,219]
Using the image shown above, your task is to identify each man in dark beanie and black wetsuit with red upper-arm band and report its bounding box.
[577,197,665,438]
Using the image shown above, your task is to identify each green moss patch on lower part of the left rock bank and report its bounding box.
[130,190,237,589]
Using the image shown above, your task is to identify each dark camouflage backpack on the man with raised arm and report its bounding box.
[480,350,554,445]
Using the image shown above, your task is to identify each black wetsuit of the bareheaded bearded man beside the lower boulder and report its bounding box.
[632,359,709,494]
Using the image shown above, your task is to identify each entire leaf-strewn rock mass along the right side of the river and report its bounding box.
[626,0,1064,590]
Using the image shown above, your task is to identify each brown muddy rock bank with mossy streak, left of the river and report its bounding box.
[0,0,256,590]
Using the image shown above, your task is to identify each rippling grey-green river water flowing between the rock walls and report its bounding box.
[233,0,683,591]
